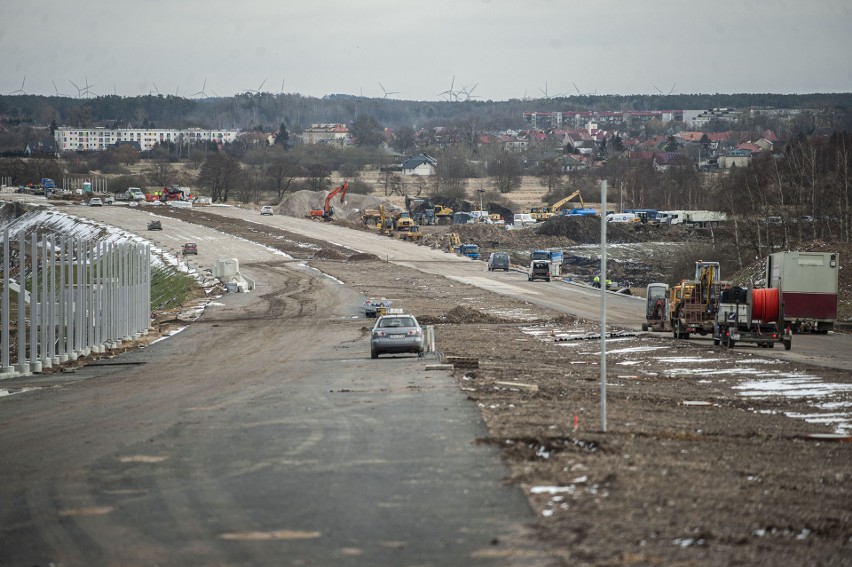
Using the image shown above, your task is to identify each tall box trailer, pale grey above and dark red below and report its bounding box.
[766,252,840,334]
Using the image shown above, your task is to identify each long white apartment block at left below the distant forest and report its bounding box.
[54,127,240,152]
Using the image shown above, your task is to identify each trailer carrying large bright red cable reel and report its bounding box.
[713,284,793,350]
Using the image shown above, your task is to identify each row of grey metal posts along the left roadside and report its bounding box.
[0,228,151,378]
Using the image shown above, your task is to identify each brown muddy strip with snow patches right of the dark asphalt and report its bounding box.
[148,206,852,566]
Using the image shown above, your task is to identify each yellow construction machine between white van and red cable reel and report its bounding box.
[669,260,725,339]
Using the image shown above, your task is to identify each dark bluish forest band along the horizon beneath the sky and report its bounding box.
[0,93,852,133]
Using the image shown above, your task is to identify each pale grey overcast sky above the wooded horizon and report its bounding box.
[0,0,852,100]
